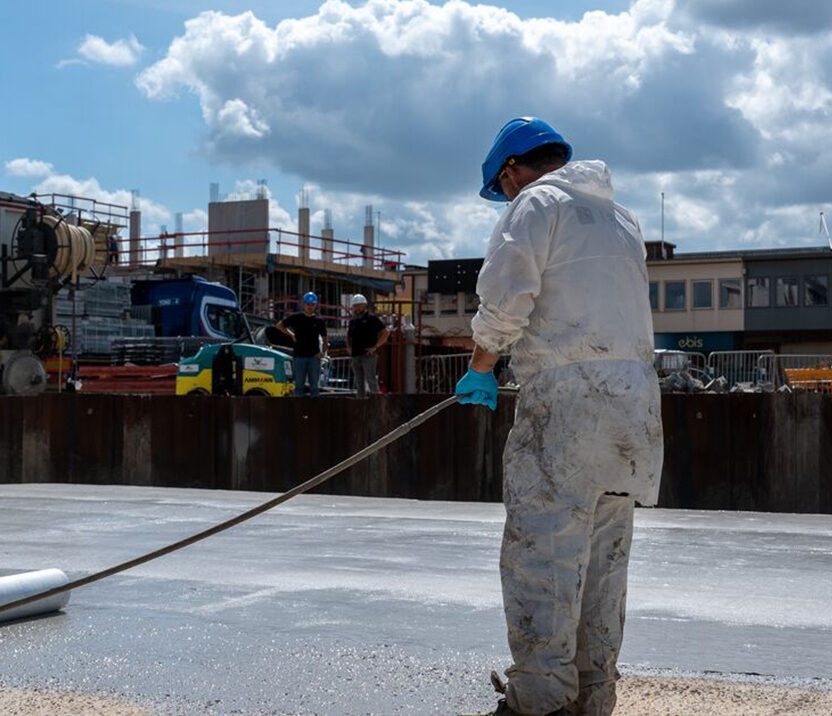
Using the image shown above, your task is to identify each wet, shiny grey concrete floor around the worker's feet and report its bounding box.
[0,485,832,715]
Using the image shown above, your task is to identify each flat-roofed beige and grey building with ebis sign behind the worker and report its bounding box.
[406,241,832,353]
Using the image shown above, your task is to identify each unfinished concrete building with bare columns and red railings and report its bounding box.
[116,187,403,330]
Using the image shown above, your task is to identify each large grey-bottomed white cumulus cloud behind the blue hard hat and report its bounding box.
[137,0,720,198]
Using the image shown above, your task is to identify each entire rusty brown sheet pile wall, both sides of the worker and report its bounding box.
[0,394,832,513]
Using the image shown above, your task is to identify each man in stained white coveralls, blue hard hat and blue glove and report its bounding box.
[456,117,662,716]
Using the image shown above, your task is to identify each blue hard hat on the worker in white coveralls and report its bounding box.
[480,117,572,201]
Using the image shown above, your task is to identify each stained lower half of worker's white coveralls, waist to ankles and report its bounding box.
[500,361,661,716]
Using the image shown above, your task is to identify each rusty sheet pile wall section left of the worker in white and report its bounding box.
[0,394,513,501]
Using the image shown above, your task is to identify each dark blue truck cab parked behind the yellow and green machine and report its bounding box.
[131,276,250,341]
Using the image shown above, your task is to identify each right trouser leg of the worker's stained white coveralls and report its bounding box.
[571,495,634,716]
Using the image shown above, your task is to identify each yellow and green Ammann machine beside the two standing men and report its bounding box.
[176,343,294,398]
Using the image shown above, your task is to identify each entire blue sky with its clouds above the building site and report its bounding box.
[0,0,832,261]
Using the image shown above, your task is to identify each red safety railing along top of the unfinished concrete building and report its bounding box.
[114,228,404,271]
